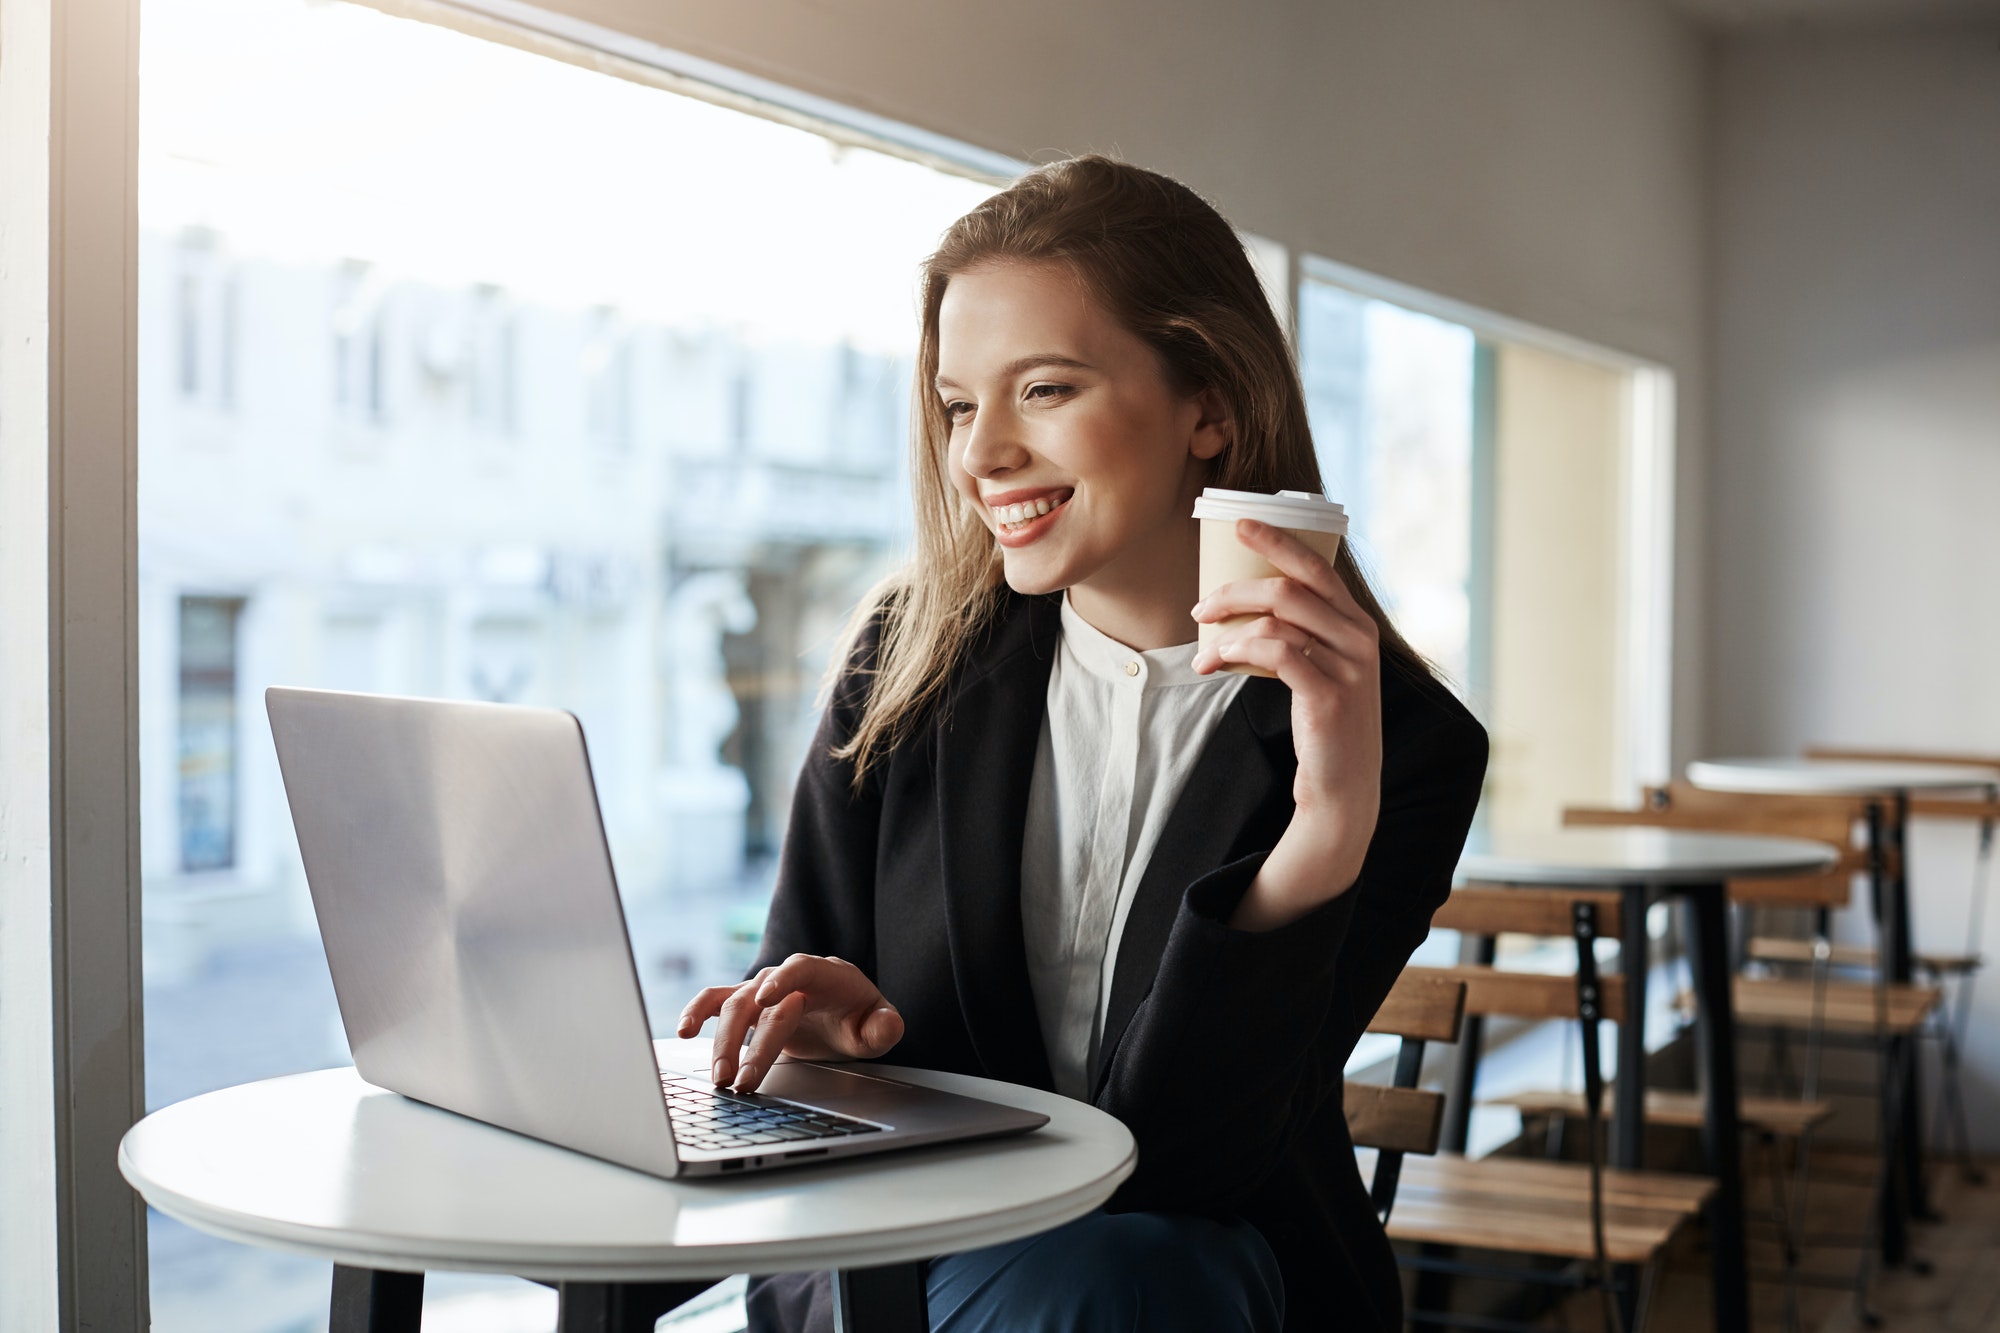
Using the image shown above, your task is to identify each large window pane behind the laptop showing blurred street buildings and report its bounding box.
[138,0,988,1312]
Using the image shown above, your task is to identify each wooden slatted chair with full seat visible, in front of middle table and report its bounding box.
[1388,889,1714,1327]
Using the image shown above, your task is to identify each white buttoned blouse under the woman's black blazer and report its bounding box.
[1020,596,1244,1099]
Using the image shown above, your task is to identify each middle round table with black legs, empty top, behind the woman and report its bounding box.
[1450,829,1840,1333]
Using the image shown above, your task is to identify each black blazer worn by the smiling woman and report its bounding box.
[752,592,1486,1329]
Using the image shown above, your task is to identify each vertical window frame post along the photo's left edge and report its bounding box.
[0,0,148,1333]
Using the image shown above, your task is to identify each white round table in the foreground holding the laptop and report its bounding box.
[118,1039,1136,1331]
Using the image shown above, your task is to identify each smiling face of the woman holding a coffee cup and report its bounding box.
[936,264,1228,642]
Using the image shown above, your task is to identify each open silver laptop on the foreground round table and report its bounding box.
[264,689,1048,1177]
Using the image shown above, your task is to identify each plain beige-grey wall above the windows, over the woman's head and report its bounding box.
[496,0,1706,753]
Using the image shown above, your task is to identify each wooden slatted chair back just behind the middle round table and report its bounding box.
[1562,781,1868,909]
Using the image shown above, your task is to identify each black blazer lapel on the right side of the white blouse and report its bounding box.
[1090,677,1298,1089]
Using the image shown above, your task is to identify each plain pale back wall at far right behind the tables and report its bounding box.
[1706,22,2000,1151]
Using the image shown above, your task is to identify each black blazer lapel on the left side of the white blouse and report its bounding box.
[936,594,1062,1089]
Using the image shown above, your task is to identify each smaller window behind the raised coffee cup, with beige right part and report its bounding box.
[1298,260,1672,829]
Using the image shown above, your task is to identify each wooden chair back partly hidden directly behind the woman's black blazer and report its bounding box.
[1344,971,1466,1223]
